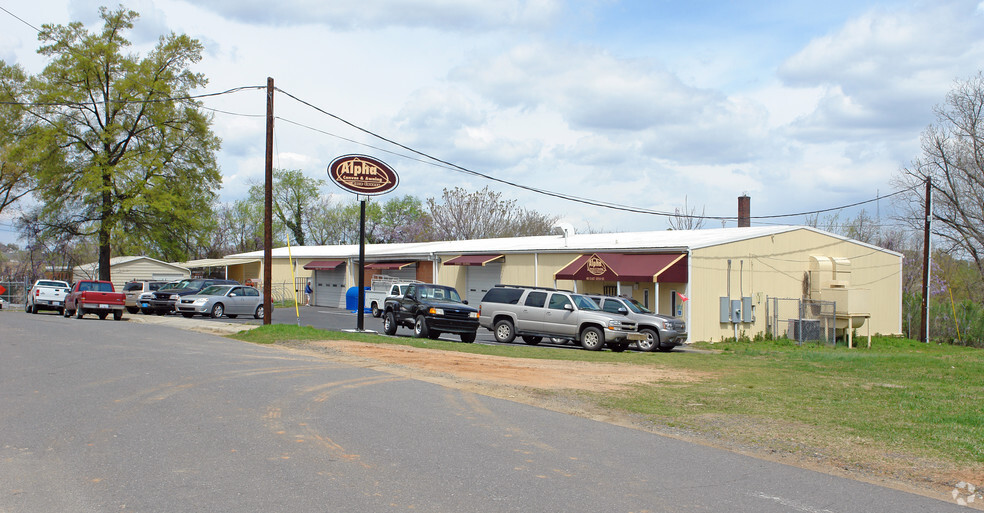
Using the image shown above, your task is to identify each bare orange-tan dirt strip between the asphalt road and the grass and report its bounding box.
[284,341,984,510]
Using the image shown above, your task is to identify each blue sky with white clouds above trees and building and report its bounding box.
[0,0,984,244]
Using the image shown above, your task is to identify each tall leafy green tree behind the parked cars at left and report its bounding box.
[16,7,221,279]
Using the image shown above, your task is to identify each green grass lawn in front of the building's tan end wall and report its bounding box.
[235,325,984,467]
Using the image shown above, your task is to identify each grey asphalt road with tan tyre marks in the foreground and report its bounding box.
[0,310,965,513]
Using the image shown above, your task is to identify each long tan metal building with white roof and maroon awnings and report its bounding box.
[230,226,902,341]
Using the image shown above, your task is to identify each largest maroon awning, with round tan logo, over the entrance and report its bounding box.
[554,253,687,283]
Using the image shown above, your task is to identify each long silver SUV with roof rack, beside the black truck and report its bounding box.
[478,285,645,351]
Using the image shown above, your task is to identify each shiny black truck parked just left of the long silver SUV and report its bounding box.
[383,283,478,343]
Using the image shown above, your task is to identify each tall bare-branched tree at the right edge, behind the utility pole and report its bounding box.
[897,72,984,274]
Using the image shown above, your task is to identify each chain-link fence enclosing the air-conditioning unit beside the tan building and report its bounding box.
[766,297,837,344]
